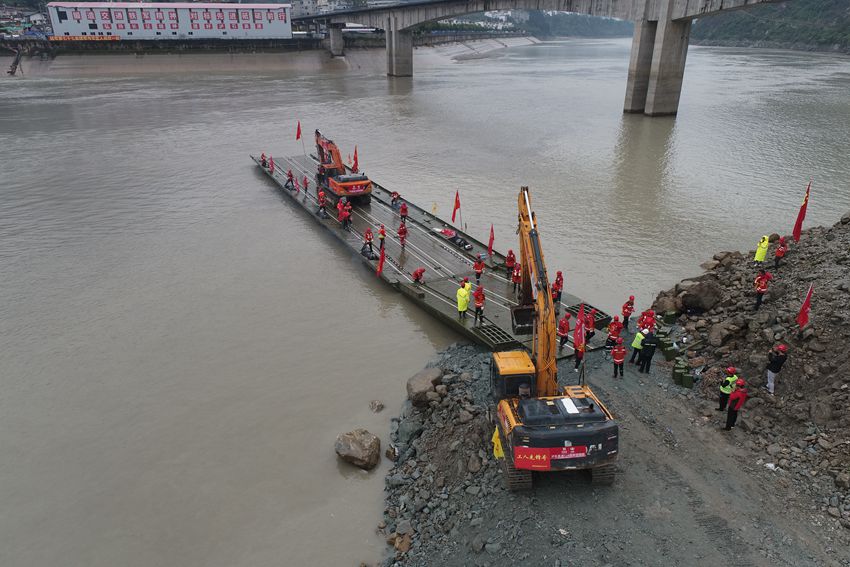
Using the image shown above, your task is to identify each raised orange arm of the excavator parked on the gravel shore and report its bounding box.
[517,187,558,396]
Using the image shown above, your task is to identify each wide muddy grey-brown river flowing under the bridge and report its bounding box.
[0,40,850,567]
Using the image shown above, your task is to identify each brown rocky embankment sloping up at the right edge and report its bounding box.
[654,213,850,528]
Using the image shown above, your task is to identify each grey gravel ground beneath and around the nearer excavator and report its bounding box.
[378,345,850,567]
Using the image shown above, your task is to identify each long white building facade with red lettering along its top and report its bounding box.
[47,2,292,41]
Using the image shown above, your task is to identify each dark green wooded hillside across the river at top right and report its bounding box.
[691,0,850,51]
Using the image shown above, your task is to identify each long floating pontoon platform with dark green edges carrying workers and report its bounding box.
[251,156,611,359]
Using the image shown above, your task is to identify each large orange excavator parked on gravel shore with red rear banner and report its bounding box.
[490,187,619,490]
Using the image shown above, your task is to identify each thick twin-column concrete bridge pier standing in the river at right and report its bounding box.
[623,0,691,116]
